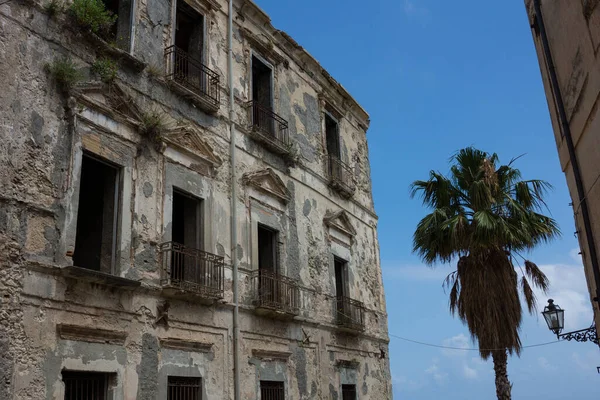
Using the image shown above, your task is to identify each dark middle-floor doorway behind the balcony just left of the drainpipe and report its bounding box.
[171,189,205,283]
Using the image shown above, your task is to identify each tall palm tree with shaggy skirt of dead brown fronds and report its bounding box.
[411,147,560,400]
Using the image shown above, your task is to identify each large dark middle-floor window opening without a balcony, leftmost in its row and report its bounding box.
[73,154,119,273]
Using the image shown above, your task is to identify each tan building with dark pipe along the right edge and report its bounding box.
[525,0,600,338]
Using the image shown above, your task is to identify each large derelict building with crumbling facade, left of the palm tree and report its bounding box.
[0,0,392,400]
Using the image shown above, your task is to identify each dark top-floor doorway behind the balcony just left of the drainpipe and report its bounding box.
[175,0,204,61]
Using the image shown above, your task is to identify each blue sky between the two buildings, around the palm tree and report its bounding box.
[257,0,600,400]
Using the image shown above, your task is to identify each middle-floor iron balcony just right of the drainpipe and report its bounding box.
[251,270,300,318]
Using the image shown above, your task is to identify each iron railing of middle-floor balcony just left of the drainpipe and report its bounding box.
[159,242,225,299]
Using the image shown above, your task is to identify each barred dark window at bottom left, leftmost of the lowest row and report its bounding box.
[62,371,110,400]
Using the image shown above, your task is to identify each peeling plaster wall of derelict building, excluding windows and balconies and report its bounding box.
[0,0,392,400]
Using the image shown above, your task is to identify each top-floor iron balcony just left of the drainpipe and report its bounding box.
[165,46,221,113]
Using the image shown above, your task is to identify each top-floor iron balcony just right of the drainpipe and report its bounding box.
[247,101,291,154]
